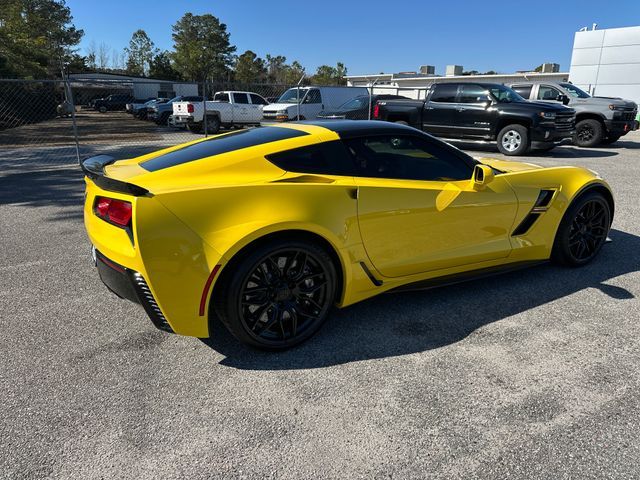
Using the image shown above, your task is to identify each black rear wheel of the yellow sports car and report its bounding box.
[211,239,337,350]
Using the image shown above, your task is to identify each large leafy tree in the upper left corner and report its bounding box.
[0,0,83,78]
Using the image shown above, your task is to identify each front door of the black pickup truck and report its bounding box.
[453,84,498,139]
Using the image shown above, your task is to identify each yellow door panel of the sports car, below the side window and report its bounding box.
[356,176,517,277]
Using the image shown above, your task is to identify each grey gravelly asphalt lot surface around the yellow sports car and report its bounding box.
[0,133,640,479]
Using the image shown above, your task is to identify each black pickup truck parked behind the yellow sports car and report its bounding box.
[373,83,576,155]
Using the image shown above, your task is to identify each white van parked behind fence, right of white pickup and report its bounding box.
[263,87,369,122]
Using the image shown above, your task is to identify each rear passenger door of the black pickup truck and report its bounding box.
[422,83,458,137]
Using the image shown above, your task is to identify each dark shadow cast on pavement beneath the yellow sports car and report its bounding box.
[202,230,640,370]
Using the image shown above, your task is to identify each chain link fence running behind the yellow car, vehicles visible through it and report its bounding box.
[0,74,410,173]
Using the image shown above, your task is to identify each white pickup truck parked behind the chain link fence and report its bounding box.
[173,91,269,133]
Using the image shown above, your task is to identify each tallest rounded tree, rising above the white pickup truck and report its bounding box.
[172,13,236,81]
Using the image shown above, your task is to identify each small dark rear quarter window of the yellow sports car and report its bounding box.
[267,140,355,176]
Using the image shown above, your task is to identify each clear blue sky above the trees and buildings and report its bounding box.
[67,0,640,74]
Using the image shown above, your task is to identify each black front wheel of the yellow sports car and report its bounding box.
[551,192,611,267]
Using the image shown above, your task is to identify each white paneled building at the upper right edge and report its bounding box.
[569,25,640,103]
